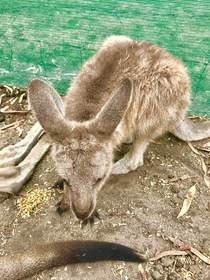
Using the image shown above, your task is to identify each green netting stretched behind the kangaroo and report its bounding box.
[0,0,210,115]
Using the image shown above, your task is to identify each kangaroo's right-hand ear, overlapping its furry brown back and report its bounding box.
[91,78,132,136]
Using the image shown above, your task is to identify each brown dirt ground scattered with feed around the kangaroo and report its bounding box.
[0,88,210,280]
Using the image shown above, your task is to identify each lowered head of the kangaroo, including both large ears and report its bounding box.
[28,79,132,220]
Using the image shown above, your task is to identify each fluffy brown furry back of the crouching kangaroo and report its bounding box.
[65,36,190,142]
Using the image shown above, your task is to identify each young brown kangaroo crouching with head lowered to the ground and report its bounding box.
[28,36,210,221]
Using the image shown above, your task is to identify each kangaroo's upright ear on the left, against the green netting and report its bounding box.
[28,78,68,140]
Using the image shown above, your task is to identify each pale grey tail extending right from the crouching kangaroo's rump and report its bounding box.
[170,116,210,141]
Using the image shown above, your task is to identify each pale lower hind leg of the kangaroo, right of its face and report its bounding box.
[111,139,148,174]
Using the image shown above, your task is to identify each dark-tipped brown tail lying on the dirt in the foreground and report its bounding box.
[0,241,146,280]
